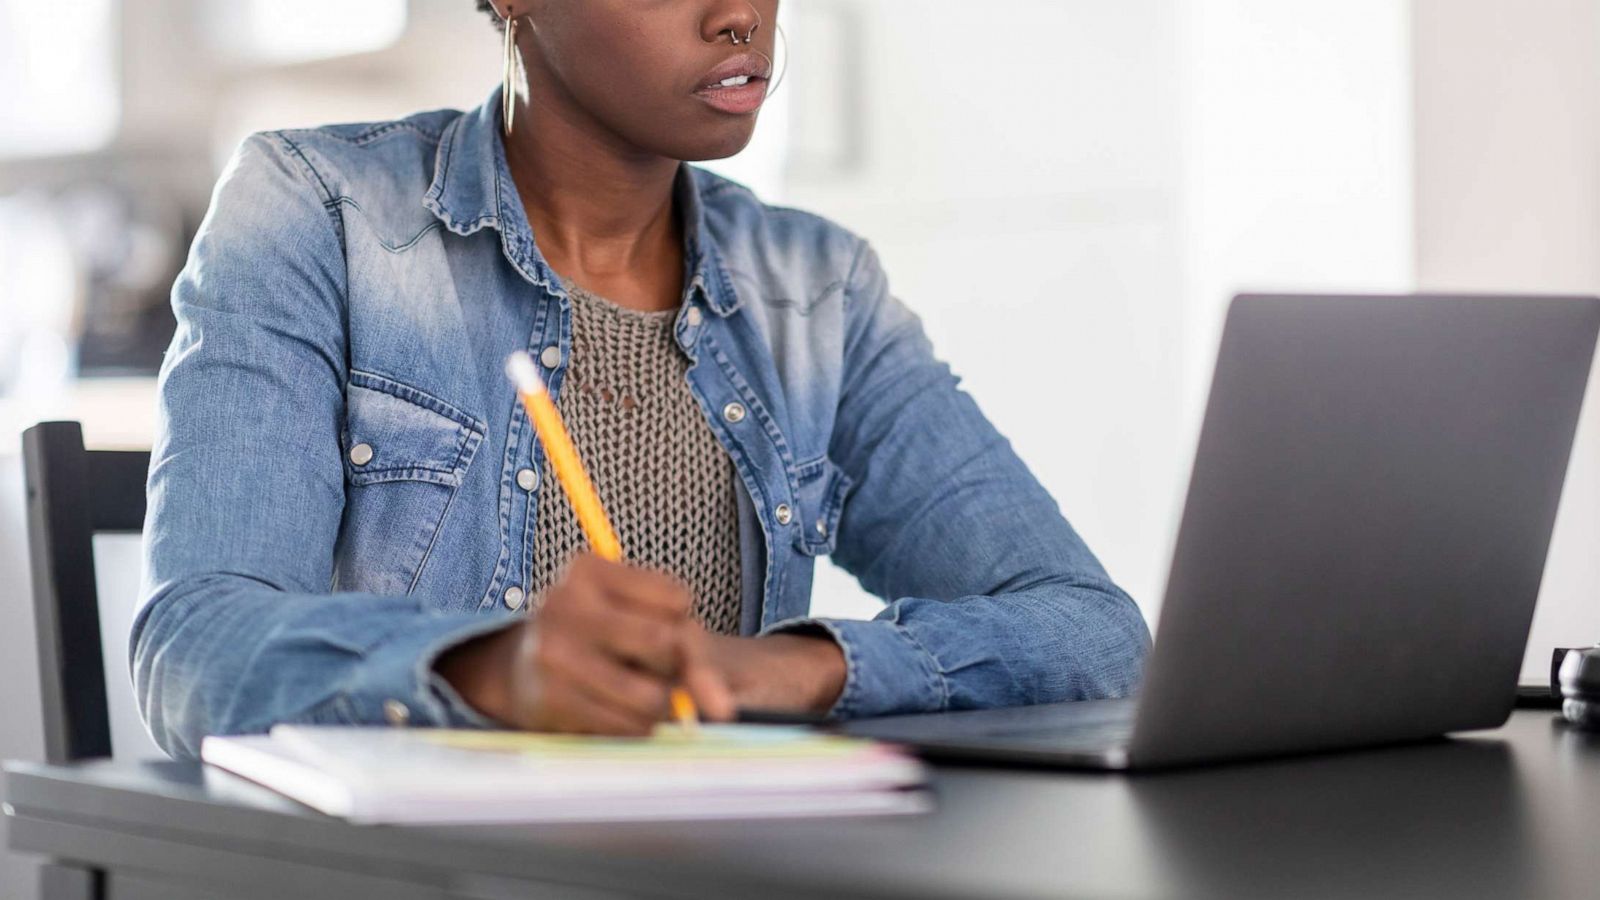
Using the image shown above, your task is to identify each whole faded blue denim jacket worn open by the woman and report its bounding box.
[130,96,1149,756]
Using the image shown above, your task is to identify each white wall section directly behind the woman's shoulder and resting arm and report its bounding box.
[787,0,1181,615]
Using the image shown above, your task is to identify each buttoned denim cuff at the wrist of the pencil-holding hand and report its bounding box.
[349,617,510,729]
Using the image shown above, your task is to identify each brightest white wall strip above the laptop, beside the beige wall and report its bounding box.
[1181,0,1414,434]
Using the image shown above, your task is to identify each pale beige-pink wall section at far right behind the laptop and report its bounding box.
[1414,0,1600,679]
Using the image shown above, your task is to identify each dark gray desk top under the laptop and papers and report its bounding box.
[8,711,1600,900]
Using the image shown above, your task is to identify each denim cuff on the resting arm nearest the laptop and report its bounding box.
[762,608,949,719]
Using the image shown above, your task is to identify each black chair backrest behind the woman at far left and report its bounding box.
[22,421,150,762]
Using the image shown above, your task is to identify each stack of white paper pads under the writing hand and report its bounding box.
[200,725,928,823]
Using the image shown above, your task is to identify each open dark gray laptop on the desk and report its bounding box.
[848,296,1600,769]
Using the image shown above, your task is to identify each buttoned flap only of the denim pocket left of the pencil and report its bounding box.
[344,372,485,487]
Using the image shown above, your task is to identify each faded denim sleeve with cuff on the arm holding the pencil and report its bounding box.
[130,135,507,756]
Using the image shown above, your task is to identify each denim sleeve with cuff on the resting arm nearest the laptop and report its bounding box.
[774,247,1150,717]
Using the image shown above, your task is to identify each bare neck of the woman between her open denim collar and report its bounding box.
[506,88,683,309]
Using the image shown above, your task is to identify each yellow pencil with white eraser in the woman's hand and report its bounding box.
[506,351,699,730]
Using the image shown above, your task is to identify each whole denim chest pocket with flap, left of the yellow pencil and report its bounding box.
[334,372,485,594]
